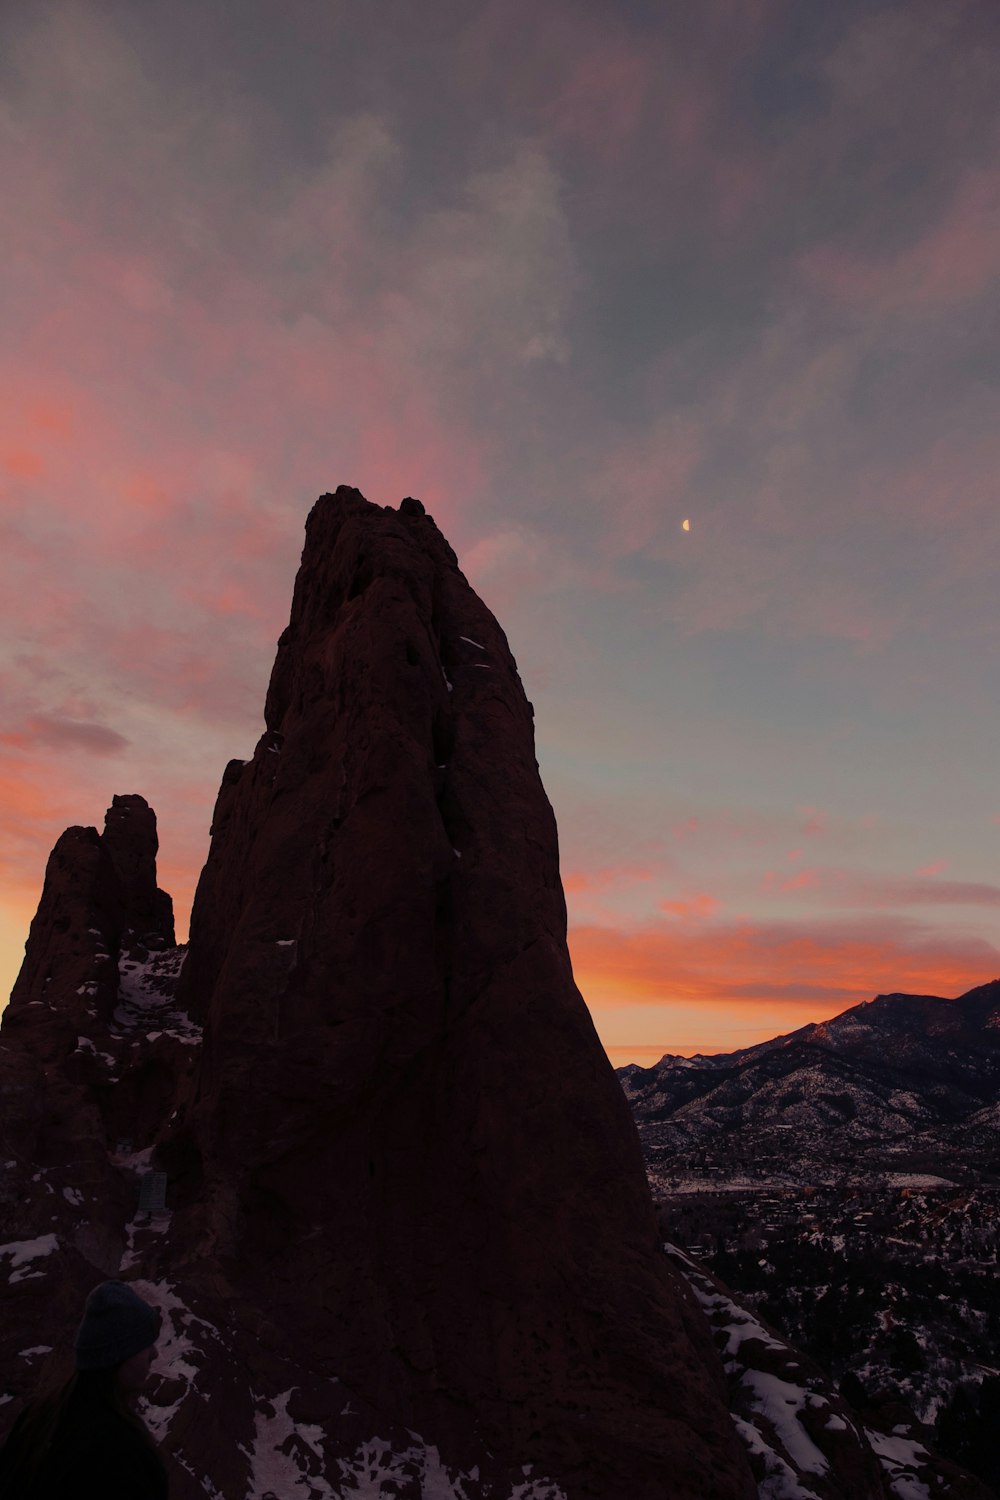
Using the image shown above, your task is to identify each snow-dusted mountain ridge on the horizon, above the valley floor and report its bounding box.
[619,980,1000,1176]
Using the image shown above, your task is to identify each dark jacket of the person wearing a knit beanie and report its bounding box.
[0,1401,166,1500]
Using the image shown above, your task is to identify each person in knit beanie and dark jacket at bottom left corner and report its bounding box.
[0,1281,166,1500]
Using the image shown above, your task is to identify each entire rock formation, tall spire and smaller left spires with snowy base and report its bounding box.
[0,488,756,1500]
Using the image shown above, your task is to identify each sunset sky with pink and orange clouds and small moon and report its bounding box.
[0,0,1000,1065]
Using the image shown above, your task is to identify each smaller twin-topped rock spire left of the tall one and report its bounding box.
[0,797,193,1418]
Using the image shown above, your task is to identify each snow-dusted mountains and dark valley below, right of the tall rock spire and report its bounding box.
[619,981,1000,1491]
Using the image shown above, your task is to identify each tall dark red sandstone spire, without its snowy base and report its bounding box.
[173,489,750,1500]
